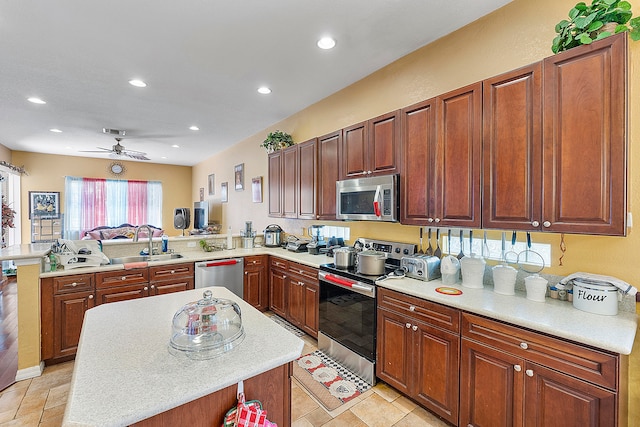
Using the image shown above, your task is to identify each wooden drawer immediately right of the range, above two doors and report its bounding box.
[378,288,460,333]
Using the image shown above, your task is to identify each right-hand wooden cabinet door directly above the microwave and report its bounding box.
[367,110,401,175]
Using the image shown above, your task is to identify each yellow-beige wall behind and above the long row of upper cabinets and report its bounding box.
[193,0,640,425]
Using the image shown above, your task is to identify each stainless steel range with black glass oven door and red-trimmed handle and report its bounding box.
[318,238,416,384]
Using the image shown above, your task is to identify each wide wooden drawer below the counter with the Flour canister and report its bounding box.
[462,313,618,390]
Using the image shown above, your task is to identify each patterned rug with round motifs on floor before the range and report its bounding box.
[293,350,371,411]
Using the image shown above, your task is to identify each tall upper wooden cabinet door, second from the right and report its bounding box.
[482,62,542,230]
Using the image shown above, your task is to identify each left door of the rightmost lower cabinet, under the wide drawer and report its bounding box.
[458,339,524,427]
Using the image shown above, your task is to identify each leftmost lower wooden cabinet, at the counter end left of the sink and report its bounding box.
[40,274,95,363]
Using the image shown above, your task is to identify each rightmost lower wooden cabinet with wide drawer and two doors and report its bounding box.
[459,313,619,427]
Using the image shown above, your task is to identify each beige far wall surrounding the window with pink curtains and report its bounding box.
[11,151,193,243]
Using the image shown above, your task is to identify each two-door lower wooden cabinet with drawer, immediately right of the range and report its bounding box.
[376,288,460,424]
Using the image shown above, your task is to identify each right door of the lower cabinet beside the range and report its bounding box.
[411,320,460,424]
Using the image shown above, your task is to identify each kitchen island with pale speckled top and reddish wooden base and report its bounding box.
[63,287,304,426]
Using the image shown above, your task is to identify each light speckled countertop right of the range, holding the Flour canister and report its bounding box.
[376,278,638,354]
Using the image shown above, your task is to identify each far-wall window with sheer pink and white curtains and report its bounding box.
[64,176,162,239]
